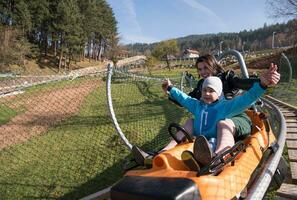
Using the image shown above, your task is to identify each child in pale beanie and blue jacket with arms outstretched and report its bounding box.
[132,64,280,167]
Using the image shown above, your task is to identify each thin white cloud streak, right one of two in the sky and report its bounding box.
[182,0,228,30]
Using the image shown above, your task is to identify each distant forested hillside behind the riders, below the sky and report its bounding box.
[126,19,297,54]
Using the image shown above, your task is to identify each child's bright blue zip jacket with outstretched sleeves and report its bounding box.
[170,83,265,139]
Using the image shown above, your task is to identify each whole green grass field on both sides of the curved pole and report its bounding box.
[0,69,297,199]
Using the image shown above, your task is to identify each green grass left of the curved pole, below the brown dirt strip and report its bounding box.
[0,84,128,199]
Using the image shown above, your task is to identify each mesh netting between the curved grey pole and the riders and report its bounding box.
[111,68,189,151]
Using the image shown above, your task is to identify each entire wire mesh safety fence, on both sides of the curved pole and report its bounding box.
[0,48,297,199]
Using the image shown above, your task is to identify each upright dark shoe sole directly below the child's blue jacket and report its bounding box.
[193,135,214,167]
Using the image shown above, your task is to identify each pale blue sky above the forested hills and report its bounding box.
[107,0,285,44]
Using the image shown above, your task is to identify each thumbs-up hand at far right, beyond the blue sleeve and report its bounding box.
[260,63,280,87]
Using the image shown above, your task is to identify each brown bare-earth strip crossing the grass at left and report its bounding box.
[0,80,100,150]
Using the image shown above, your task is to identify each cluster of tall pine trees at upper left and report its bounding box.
[0,0,118,70]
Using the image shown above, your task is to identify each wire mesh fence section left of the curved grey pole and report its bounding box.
[0,70,125,199]
